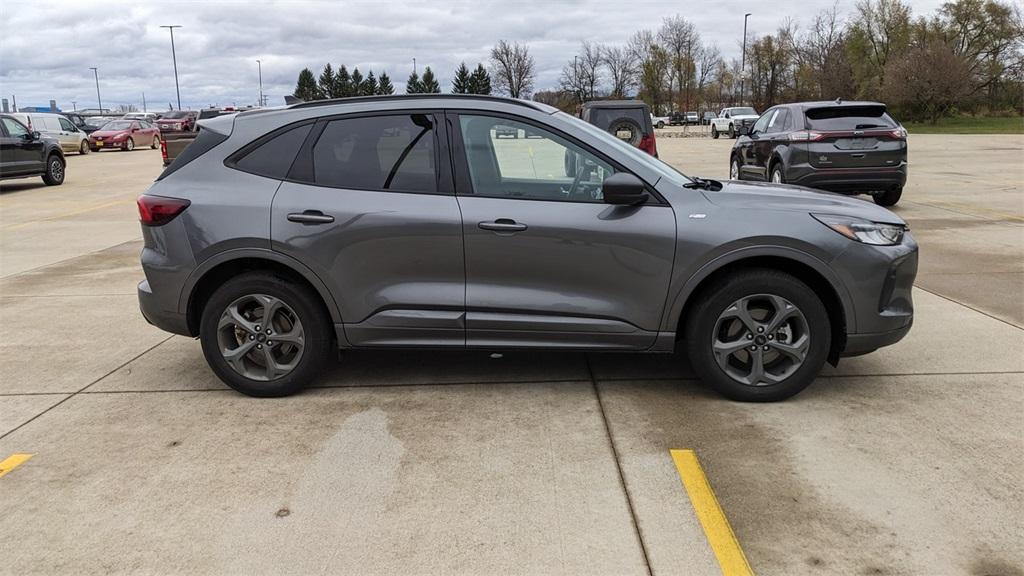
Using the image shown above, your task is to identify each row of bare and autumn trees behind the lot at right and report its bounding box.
[535,0,1024,122]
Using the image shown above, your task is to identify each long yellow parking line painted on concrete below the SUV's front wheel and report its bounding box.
[670,450,754,576]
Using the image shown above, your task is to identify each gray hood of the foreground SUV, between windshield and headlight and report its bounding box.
[705,181,906,225]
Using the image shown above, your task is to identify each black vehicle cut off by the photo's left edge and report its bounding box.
[0,114,65,186]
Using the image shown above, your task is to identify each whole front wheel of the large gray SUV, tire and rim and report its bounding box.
[686,270,831,402]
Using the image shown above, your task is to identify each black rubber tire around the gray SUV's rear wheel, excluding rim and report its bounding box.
[200,272,334,398]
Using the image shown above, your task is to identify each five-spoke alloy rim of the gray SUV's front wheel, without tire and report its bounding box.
[711,294,811,386]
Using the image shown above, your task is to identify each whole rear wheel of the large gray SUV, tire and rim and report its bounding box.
[200,273,332,391]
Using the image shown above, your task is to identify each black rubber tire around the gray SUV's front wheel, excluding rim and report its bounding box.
[685,269,831,402]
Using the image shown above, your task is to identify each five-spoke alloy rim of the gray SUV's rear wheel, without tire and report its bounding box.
[217,294,305,381]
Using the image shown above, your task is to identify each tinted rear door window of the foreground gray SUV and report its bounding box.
[312,114,437,193]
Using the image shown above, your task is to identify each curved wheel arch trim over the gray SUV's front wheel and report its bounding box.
[662,241,857,333]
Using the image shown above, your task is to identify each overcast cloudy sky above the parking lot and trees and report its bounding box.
[0,0,942,110]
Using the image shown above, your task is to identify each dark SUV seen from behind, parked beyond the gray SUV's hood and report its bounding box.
[729,100,907,206]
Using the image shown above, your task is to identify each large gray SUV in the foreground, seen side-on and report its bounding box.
[138,94,918,401]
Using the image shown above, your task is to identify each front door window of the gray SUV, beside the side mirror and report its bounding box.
[459,115,615,202]
